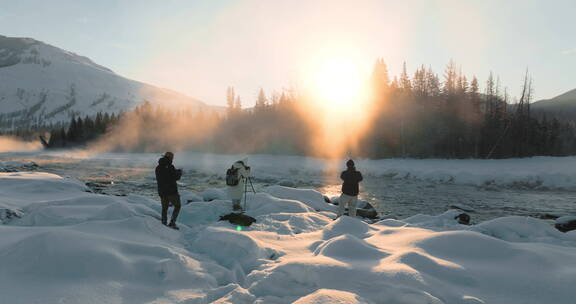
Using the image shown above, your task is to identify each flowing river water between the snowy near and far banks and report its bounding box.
[0,152,576,223]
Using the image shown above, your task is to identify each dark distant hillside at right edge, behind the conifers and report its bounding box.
[532,89,576,121]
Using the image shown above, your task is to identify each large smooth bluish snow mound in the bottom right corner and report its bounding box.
[415,231,576,303]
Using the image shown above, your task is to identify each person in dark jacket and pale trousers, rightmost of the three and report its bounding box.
[338,159,362,217]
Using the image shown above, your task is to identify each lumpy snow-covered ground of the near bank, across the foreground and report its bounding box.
[0,170,576,304]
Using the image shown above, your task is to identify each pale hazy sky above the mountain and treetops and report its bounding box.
[0,0,576,105]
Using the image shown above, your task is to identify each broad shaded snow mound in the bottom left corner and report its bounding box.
[0,218,217,303]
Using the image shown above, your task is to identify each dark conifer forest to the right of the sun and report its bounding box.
[361,60,576,158]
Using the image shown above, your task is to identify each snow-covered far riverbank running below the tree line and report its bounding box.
[6,151,576,191]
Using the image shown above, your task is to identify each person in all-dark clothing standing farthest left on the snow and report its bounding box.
[156,152,182,229]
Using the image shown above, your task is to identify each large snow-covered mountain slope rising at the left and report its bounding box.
[0,35,218,129]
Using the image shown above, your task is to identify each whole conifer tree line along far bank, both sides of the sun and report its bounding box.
[16,59,576,158]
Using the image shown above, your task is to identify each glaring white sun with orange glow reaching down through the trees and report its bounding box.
[303,54,370,159]
